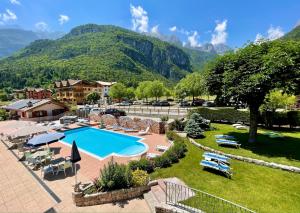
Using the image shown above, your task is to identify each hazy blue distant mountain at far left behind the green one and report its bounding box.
[0,26,62,58]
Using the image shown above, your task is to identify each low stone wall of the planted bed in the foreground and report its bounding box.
[72,181,157,206]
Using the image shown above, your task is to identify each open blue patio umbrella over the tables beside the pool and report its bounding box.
[27,132,65,146]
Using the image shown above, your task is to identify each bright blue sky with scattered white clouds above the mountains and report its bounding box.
[0,0,300,48]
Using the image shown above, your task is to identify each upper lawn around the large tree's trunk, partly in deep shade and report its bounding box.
[196,124,300,167]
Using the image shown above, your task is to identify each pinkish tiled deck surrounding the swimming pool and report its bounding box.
[0,120,170,212]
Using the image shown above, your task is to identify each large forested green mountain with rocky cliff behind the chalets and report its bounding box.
[0,24,209,88]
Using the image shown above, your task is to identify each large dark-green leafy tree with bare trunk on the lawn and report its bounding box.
[207,41,300,142]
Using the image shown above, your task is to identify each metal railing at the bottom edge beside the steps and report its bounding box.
[165,182,255,213]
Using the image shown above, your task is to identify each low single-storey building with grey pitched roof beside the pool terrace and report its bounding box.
[2,99,68,121]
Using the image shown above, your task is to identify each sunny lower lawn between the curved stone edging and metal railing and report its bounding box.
[151,136,300,213]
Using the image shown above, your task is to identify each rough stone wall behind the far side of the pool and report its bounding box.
[89,115,166,134]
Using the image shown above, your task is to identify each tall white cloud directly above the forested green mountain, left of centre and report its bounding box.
[130,5,149,33]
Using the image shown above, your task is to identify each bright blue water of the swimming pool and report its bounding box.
[62,127,147,158]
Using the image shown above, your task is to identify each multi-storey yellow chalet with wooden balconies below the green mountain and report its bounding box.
[54,79,115,104]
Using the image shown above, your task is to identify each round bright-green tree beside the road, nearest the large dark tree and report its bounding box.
[176,72,206,101]
